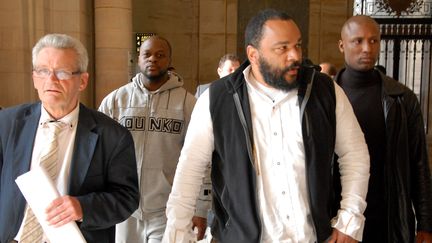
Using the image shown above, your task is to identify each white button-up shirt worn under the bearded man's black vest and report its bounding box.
[163,66,369,243]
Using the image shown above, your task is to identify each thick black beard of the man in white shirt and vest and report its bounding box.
[258,55,300,91]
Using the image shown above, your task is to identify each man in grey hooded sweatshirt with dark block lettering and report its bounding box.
[99,36,208,243]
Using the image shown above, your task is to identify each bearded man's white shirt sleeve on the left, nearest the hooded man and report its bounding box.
[162,90,214,243]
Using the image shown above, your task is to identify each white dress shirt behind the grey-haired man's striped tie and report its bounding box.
[15,104,79,242]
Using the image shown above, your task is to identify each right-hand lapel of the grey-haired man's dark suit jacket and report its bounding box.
[69,105,99,195]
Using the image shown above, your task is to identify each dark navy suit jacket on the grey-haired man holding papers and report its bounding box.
[0,103,139,243]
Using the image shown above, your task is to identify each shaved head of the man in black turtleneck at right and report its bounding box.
[339,15,381,71]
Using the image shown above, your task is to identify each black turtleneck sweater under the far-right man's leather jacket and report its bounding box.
[338,67,387,242]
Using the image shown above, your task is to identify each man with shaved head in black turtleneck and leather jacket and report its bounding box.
[336,16,432,243]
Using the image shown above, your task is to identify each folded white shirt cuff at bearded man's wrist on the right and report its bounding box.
[331,209,365,241]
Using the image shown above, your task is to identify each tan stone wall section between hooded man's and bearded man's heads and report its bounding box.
[133,0,237,92]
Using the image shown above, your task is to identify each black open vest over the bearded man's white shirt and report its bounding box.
[210,62,336,243]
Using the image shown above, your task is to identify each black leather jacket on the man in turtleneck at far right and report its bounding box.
[336,70,432,243]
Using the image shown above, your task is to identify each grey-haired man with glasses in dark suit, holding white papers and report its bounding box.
[0,34,139,243]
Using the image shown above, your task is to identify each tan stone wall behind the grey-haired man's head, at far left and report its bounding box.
[0,0,94,106]
